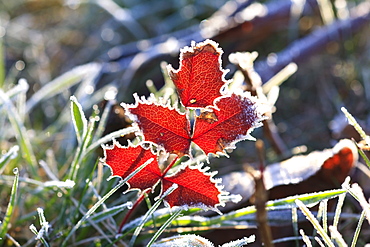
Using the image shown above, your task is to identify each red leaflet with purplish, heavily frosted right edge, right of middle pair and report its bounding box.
[192,94,262,154]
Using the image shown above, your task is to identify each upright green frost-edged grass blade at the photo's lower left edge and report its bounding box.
[0,168,19,241]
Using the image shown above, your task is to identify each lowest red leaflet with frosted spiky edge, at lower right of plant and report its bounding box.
[162,166,223,210]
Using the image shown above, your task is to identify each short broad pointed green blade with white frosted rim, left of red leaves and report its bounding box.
[70,96,87,144]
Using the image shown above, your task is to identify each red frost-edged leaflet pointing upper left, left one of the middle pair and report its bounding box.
[123,94,191,156]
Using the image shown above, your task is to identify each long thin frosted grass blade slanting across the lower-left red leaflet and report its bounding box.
[61,159,153,247]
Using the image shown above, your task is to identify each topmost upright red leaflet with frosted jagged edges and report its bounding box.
[168,40,228,108]
